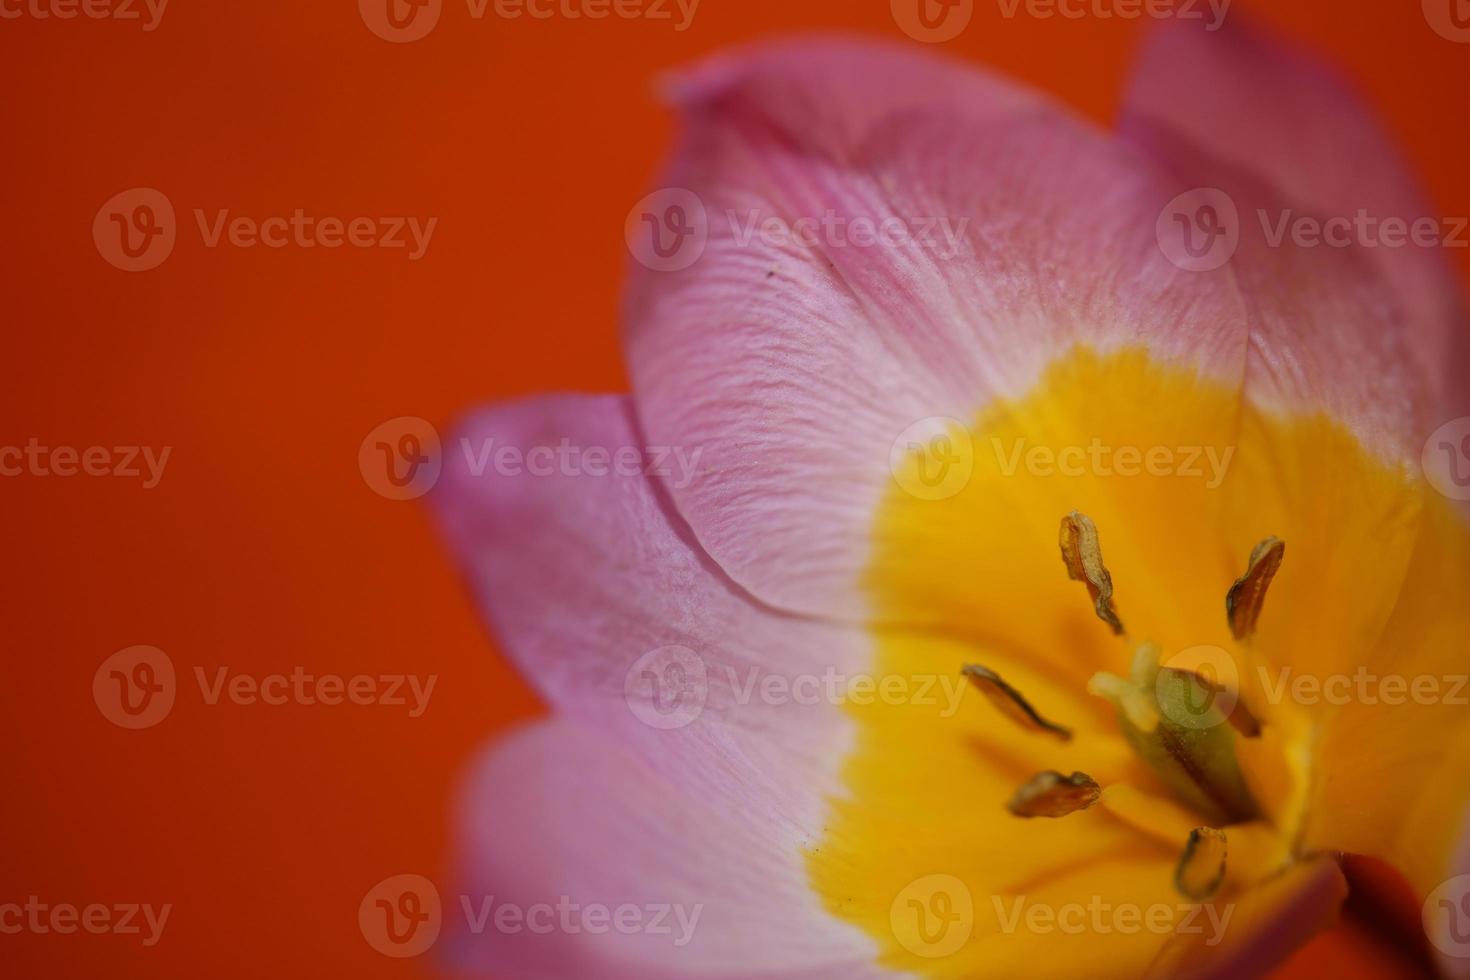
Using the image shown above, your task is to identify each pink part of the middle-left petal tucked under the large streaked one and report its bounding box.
[435,397,870,861]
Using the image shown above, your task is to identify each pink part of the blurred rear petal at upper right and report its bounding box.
[1122,14,1470,449]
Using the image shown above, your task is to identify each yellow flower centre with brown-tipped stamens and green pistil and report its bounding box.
[807,348,1470,977]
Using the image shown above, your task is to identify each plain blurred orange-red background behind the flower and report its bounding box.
[0,0,1470,977]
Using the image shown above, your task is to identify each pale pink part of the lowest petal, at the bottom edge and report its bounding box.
[445,720,883,980]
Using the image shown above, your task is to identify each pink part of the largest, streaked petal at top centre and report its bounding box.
[626,43,1245,616]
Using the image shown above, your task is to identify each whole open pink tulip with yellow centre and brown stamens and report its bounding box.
[437,17,1470,977]
